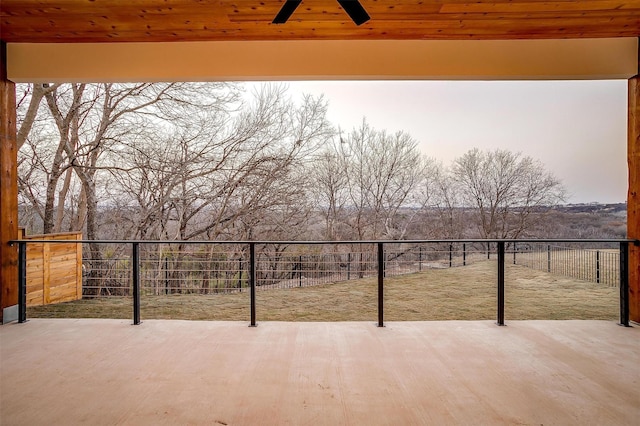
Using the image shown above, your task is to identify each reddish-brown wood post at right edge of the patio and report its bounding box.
[627,55,640,322]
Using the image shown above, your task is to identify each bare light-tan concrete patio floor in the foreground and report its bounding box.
[0,319,640,426]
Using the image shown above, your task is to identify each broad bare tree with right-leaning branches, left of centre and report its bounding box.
[105,85,332,240]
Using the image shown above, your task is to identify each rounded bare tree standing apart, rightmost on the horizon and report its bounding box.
[451,149,565,238]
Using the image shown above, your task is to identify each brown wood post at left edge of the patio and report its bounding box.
[0,41,18,323]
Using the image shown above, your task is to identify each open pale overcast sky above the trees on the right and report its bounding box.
[248,80,627,203]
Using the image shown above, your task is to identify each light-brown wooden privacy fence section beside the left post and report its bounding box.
[21,232,82,306]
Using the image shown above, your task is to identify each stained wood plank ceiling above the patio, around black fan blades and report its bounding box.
[0,0,640,43]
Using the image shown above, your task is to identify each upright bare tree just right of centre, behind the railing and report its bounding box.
[309,121,424,277]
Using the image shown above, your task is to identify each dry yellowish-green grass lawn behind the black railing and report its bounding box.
[27,260,619,322]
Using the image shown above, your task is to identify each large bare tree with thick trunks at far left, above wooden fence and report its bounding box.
[21,83,242,235]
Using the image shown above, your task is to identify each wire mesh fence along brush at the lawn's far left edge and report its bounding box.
[83,243,510,298]
